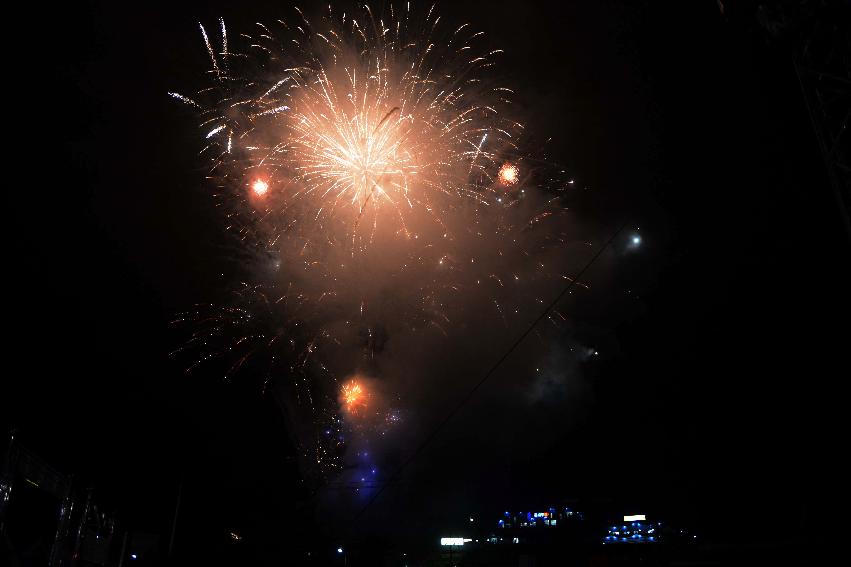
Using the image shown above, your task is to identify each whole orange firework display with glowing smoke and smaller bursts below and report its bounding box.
[169,4,584,486]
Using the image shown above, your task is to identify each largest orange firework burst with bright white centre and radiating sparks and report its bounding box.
[172,4,522,252]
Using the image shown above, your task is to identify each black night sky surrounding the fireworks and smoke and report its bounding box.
[0,0,851,560]
